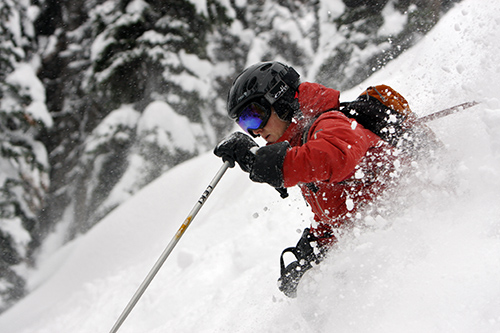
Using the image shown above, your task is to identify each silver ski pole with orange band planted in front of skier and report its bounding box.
[110,162,229,333]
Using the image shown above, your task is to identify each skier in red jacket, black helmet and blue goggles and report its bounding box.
[214,62,404,297]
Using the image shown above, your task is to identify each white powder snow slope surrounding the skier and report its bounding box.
[0,0,500,333]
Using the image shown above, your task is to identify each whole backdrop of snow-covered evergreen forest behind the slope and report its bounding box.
[0,0,458,312]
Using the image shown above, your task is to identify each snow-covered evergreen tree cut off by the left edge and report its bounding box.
[0,0,52,311]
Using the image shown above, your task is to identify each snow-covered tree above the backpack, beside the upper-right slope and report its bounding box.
[316,0,458,90]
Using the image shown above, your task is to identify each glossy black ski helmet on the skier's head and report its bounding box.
[227,61,300,120]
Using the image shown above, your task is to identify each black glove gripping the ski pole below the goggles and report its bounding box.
[214,132,259,172]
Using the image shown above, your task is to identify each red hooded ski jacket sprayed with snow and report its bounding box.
[278,82,395,245]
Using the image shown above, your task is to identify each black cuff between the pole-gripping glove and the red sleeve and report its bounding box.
[250,141,290,187]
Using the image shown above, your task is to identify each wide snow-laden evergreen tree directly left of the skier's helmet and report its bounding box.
[37,0,233,237]
